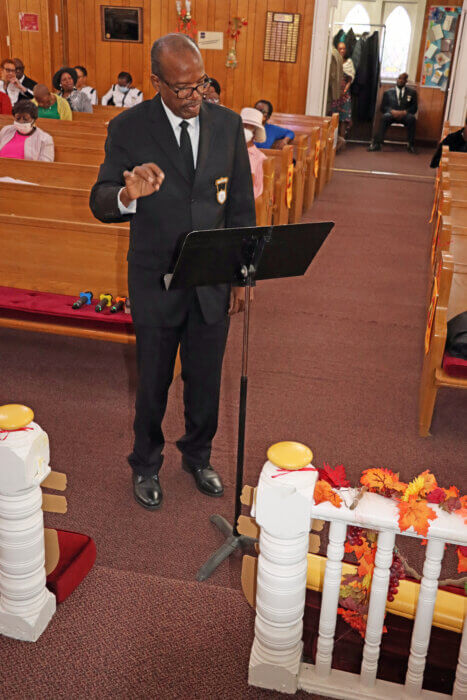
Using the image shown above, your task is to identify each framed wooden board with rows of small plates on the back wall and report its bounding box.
[264,12,300,63]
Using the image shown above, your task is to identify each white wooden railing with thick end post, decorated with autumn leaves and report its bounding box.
[249,452,467,700]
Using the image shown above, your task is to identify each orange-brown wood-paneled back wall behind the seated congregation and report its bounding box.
[0,0,314,113]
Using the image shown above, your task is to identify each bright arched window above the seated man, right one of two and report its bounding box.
[381,5,412,78]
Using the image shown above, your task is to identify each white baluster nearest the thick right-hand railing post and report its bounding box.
[316,520,347,677]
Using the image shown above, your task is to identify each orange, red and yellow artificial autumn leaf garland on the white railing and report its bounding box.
[314,464,467,638]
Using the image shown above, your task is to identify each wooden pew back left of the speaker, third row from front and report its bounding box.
[0,158,99,189]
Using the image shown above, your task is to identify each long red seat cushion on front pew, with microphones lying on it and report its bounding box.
[0,287,133,325]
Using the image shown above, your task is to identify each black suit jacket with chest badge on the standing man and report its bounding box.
[90,95,256,327]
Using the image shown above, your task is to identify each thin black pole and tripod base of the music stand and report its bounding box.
[196,265,257,581]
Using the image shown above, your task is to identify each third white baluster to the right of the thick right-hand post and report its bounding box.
[405,539,444,697]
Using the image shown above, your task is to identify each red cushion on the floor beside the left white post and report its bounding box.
[47,530,96,603]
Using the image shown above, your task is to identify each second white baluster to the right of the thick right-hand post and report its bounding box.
[361,532,396,687]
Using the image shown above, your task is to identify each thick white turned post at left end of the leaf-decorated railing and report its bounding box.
[249,452,316,693]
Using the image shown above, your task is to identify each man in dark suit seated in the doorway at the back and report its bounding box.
[368,73,418,153]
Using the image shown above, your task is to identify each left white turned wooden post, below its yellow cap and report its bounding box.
[0,416,55,642]
